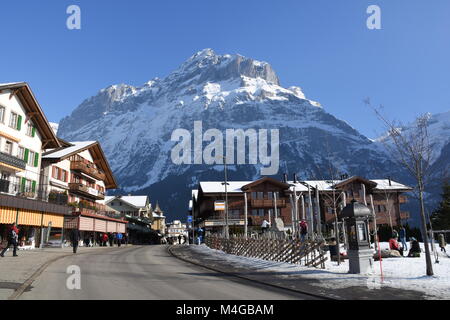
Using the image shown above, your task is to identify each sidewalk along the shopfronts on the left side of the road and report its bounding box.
[0,247,121,300]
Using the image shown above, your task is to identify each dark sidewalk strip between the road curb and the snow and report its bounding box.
[171,245,427,300]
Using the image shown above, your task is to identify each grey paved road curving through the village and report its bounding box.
[20,246,309,300]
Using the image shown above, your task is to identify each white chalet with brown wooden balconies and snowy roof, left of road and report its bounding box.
[41,140,126,243]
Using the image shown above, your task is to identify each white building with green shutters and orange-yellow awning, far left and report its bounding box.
[0,82,69,248]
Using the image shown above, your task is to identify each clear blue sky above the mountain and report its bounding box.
[0,0,450,137]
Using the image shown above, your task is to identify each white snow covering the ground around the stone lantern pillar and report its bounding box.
[193,243,450,299]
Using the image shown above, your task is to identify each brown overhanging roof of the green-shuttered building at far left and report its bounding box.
[0,82,61,148]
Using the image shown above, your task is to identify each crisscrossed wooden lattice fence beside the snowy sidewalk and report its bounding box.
[205,235,327,269]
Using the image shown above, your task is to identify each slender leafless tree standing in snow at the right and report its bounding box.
[364,98,433,276]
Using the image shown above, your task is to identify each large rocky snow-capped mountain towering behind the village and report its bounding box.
[58,49,440,217]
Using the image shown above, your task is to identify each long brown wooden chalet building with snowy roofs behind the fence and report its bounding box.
[190,177,412,233]
